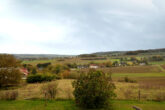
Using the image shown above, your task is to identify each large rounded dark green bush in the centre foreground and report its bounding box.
[73,70,115,109]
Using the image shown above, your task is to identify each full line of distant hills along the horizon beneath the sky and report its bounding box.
[2,48,165,59]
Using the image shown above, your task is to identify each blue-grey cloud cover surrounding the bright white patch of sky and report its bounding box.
[0,0,165,53]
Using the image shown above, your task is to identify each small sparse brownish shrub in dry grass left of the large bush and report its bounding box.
[41,83,58,99]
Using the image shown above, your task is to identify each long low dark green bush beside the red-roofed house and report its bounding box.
[26,74,56,83]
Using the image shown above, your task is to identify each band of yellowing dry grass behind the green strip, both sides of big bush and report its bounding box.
[0,78,165,100]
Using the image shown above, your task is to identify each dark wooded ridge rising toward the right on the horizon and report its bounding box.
[92,48,165,56]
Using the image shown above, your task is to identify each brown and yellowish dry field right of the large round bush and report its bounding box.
[115,77,165,100]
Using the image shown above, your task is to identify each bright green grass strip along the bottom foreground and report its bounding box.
[0,100,165,110]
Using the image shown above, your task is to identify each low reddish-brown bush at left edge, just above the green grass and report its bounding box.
[0,91,18,100]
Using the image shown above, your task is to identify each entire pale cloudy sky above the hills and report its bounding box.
[0,0,165,55]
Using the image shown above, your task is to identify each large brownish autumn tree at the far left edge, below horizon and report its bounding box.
[0,54,21,87]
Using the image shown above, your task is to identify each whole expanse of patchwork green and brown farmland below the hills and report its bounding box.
[0,52,165,110]
